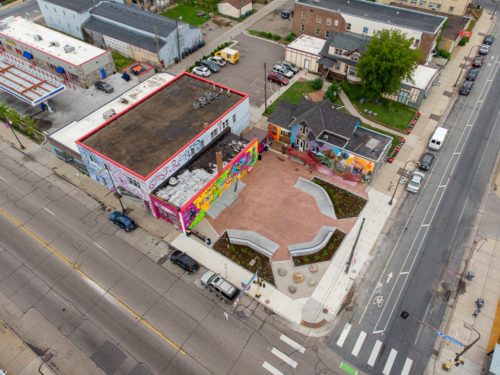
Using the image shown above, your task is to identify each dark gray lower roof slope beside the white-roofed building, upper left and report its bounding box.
[82,16,167,53]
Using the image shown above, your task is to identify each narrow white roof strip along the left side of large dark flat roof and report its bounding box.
[50,73,175,155]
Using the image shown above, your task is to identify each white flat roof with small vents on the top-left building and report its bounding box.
[0,16,107,65]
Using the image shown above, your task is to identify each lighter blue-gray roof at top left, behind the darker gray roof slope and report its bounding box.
[90,2,178,37]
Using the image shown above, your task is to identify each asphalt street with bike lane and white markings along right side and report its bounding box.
[329,26,500,375]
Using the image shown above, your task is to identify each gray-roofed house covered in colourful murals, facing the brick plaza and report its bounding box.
[268,99,392,183]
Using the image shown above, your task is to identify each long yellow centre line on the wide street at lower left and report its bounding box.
[0,207,186,355]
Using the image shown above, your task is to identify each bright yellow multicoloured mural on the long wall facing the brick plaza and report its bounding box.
[182,140,258,229]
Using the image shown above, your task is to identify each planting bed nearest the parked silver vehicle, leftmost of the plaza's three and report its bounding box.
[213,232,276,285]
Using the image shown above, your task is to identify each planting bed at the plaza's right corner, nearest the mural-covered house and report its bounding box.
[313,177,366,219]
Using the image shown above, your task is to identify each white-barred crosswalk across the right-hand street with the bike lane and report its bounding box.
[335,323,413,375]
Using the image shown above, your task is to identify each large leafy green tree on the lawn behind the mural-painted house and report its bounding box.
[358,29,423,99]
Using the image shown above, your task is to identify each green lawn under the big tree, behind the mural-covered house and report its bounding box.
[344,84,417,131]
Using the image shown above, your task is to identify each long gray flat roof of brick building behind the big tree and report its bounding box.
[295,0,446,34]
